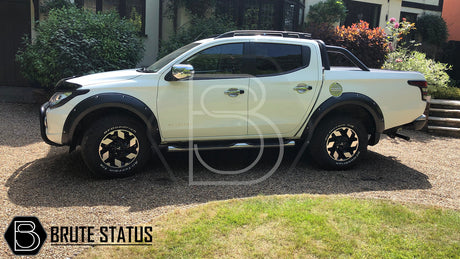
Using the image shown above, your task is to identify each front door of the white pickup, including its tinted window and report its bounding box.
[157,43,249,141]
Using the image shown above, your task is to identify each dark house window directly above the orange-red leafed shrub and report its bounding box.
[344,0,382,28]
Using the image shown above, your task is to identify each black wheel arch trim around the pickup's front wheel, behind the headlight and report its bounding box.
[62,93,159,150]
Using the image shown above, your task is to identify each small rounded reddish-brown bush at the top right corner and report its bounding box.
[416,14,449,46]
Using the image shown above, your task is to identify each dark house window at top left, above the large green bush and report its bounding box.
[75,0,145,33]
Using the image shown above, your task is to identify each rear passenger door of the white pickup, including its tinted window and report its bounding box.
[248,42,321,137]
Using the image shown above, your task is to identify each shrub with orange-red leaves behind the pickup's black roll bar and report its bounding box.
[335,21,388,68]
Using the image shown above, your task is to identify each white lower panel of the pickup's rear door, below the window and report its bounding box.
[248,66,321,137]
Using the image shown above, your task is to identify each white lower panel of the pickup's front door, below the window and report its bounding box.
[157,78,249,141]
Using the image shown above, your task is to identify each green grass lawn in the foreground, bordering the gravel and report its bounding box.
[80,195,460,258]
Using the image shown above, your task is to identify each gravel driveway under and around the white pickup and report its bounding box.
[0,103,460,258]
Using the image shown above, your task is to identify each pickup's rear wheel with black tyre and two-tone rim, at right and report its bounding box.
[309,117,368,170]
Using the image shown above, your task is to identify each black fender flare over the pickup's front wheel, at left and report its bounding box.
[62,93,158,145]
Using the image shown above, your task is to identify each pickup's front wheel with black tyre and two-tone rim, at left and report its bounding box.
[81,115,150,178]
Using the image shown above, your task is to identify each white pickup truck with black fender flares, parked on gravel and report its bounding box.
[40,31,427,178]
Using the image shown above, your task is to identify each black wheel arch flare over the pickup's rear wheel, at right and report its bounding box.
[302,93,385,145]
